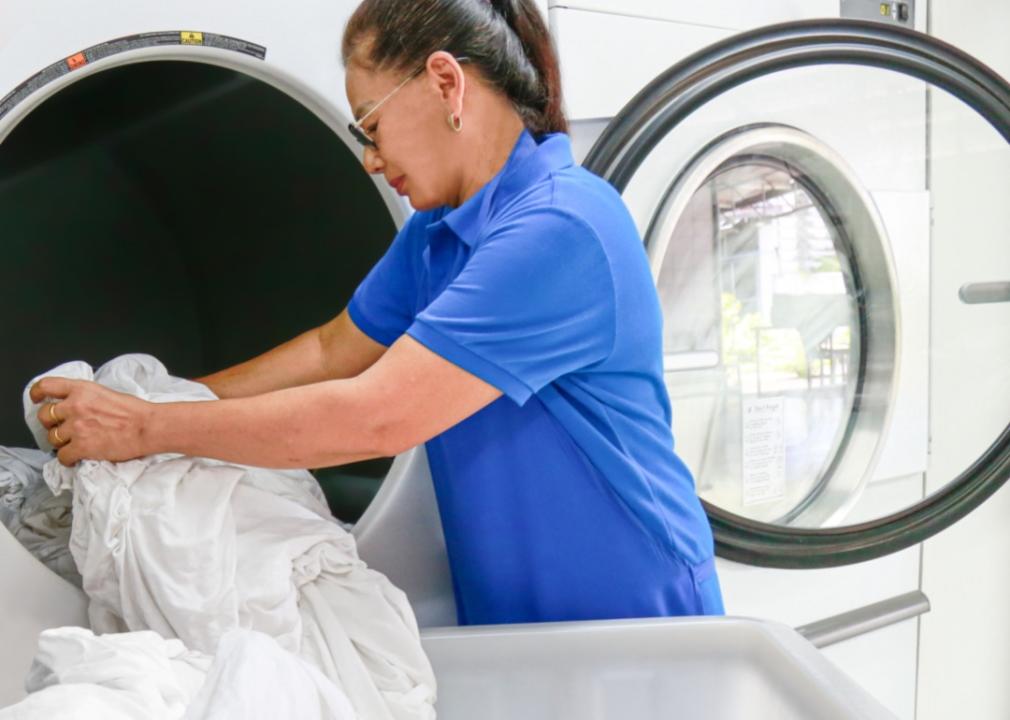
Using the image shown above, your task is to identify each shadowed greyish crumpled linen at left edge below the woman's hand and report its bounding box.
[0,446,81,588]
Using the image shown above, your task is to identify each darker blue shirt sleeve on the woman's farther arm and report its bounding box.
[347,213,424,346]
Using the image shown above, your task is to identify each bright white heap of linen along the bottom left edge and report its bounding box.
[0,627,361,720]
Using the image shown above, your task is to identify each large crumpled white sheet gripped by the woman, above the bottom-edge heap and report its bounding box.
[8,354,435,720]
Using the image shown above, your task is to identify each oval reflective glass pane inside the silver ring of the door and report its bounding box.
[658,156,860,523]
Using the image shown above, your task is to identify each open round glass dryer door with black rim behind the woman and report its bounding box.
[585,21,1010,568]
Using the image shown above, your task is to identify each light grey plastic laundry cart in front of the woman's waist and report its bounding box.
[423,618,894,720]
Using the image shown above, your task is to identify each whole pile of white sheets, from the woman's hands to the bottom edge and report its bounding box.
[0,354,435,720]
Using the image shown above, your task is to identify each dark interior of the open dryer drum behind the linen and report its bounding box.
[0,62,396,521]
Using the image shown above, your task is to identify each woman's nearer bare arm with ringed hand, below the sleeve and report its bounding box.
[31,335,501,468]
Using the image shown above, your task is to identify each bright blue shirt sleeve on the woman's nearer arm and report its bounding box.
[407,208,616,405]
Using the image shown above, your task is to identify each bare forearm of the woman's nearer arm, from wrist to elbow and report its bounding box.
[144,380,386,468]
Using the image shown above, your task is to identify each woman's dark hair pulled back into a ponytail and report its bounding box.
[341,0,568,134]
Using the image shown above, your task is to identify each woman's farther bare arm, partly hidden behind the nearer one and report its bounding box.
[196,310,386,398]
